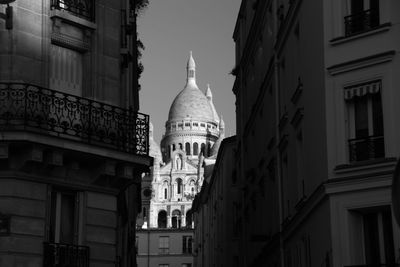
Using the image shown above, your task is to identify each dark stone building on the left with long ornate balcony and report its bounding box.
[0,0,152,266]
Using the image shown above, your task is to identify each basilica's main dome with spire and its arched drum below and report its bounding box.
[161,52,219,163]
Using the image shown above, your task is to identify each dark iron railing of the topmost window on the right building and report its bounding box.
[344,9,379,36]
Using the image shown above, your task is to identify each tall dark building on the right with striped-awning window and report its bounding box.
[228,0,400,267]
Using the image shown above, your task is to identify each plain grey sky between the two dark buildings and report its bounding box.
[138,0,240,143]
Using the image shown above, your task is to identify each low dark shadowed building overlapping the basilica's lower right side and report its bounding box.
[193,136,240,267]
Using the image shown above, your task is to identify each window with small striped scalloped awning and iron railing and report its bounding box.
[344,80,385,162]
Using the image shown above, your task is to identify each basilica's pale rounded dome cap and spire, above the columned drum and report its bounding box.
[168,53,215,121]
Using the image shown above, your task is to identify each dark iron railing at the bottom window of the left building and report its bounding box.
[43,242,90,267]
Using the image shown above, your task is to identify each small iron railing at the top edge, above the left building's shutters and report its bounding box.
[51,0,95,21]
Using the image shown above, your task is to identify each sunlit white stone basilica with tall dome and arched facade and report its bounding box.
[137,53,224,229]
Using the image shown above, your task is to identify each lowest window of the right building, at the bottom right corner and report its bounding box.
[350,206,395,266]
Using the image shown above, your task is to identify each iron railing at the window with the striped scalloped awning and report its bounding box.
[349,136,385,162]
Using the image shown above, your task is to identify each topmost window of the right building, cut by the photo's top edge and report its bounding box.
[344,0,379,36]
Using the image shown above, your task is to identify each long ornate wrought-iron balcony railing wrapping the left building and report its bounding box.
[0,82,149,155]
